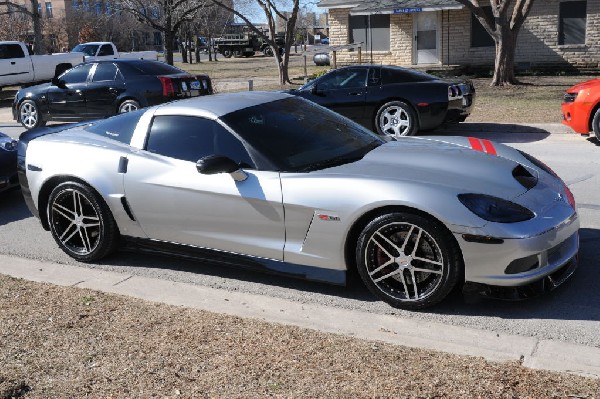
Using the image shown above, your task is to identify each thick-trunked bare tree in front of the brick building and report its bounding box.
[456,0,535,86]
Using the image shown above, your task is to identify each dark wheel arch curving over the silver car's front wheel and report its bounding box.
[344,205,465,282]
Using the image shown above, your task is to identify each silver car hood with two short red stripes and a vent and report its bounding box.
[322,137,538,199]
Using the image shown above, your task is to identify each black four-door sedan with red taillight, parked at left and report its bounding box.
[13,59,212,129]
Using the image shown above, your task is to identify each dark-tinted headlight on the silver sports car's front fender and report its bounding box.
[458,194,535,223]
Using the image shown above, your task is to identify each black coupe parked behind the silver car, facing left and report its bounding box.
[290,65,475,137]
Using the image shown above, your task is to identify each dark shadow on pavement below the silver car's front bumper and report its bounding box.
[433,228,600,321]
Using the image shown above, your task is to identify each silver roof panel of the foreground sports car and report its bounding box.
[154,91,292,118]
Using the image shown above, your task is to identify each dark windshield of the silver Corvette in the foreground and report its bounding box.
[222,97,384,172]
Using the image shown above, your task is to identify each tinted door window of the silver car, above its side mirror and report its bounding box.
[146,115,254,168]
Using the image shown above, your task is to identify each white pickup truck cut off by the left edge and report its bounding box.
[0,42,83,89]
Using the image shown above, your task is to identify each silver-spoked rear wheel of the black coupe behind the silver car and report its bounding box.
[375,101,419,138]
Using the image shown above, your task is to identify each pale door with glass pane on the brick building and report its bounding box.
[413,11,440,64]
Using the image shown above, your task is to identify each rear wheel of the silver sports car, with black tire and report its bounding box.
[47,182,119,262]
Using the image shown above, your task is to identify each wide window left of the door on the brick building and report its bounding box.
[348,14,390,51]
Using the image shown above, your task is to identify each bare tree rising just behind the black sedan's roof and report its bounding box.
[122,0,207,65]
